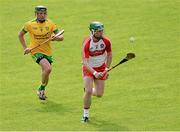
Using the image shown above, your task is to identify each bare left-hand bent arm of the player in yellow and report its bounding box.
[18,30,31,54]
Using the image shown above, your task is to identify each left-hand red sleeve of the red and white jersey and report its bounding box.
[82,38,90,58]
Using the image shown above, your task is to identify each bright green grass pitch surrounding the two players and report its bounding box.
[0,0,180,131]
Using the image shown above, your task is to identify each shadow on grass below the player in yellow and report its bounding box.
[36,100,71,115]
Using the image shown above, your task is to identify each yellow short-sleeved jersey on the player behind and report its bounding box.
[22,19,59,56]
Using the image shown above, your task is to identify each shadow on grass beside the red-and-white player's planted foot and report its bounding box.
[88,117,128,131]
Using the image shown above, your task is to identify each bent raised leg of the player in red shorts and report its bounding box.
[93,79,105,97]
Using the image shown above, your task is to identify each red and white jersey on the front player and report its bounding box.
[82,36,111,68]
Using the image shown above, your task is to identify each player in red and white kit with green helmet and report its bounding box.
[81,22,112,122]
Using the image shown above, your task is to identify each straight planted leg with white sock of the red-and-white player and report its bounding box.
[82,76,93,122]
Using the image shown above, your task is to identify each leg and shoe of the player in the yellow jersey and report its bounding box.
[39,58,52,100]
